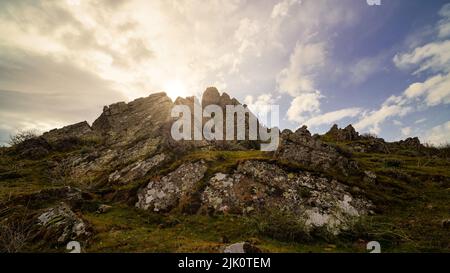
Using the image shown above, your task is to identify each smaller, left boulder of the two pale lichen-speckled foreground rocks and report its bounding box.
[136,161,207,211]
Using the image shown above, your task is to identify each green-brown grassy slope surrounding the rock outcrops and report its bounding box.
[0,146,450,252]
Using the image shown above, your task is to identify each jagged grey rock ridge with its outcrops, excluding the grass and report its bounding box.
[0,87,446,253]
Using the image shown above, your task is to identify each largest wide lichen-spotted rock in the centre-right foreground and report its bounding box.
[202,161,372,234]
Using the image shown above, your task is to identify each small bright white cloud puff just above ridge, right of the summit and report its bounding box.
[287,92,322,123]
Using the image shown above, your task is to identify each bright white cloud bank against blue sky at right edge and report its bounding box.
[355,5,450,134]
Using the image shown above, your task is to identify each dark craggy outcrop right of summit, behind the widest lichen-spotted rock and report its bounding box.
[275,126,357,175]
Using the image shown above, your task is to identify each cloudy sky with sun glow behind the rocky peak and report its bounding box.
[0,0,450,145]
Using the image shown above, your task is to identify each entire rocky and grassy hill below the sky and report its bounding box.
[0,87,450,252]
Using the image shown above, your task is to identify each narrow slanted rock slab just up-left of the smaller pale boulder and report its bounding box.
[108,154,167,183]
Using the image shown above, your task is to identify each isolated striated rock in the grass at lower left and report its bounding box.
[37,203,90,243]
